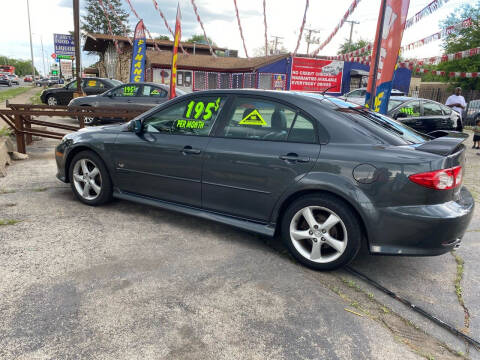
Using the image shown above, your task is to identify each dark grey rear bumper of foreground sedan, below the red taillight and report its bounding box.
[369,187,475,256]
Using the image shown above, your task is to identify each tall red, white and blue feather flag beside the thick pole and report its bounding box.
[365,0,410,114]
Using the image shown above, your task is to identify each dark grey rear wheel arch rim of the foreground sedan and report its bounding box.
[273,188,370,250]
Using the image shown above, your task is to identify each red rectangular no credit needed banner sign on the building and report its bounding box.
[290,57,343,93]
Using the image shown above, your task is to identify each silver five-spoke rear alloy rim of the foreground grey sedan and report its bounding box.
[290,206,348,263]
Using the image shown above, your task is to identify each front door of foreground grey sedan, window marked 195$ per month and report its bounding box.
[113,96,226,207]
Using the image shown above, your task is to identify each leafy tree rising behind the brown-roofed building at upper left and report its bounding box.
[81,0,130,35]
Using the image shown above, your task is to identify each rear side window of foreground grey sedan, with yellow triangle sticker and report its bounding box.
[220,97,316,143]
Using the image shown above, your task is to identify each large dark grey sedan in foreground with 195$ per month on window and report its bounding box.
[55,90,474,270]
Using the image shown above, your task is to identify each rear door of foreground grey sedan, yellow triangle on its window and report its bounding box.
[202,96,320,222]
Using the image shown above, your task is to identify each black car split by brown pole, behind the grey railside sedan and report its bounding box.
[40,78,122,106]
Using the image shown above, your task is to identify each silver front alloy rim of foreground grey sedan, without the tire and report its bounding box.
[73,159,102,200]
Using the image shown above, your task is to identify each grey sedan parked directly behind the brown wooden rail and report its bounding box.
[68,82,185,125]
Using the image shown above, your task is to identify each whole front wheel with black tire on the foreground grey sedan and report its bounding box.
[68,151,112,206]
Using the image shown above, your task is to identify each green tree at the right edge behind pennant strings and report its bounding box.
[422,1,480,90]
